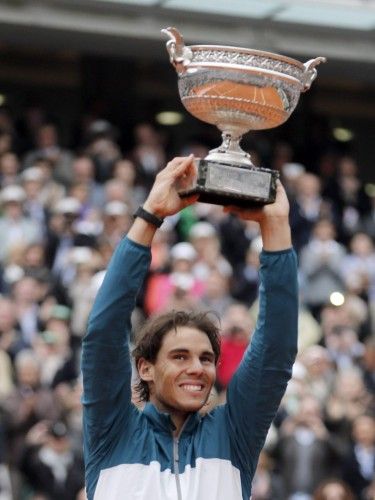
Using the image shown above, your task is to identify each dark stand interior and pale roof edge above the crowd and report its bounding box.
[0,0,375,181]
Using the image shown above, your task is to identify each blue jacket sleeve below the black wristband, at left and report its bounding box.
[82,238,150,456]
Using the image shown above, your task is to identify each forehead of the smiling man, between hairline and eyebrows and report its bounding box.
[159,326,213,353]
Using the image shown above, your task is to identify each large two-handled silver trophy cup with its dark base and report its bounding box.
[162,28,326,207]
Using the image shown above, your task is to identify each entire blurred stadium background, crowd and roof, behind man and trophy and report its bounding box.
[0,0,375,500]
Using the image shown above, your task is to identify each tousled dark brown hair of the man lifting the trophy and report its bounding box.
[132,311,220,401]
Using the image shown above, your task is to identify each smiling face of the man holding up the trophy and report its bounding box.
[147,326,216,415]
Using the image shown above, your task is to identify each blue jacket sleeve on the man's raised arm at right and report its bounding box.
[226,249,298,477]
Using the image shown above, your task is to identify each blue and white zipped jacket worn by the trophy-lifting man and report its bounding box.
[82,238,298,500]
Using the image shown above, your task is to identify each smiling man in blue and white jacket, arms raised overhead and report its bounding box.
[82,156,298,500]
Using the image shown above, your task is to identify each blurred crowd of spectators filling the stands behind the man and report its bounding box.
[0,106,375,500]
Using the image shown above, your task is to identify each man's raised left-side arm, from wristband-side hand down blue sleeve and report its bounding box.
[82,157,195,457]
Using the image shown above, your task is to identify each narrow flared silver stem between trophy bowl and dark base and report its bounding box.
[205,130,254,167]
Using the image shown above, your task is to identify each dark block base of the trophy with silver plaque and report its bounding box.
[178,160,279,208]
